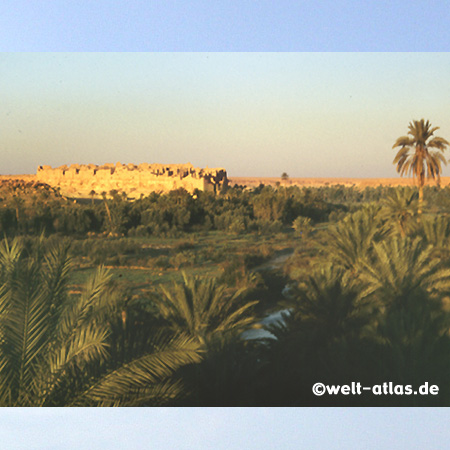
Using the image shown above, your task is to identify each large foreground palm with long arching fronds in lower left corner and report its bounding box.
[0,240,200,406]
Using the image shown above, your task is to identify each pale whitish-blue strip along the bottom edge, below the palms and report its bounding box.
[0,408,450,450]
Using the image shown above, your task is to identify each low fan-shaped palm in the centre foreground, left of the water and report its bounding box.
[155,272,261,406]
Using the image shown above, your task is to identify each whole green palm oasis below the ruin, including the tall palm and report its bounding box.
[0,120,450,406]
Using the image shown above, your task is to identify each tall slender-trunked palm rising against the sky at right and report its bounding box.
[392,119,450,215]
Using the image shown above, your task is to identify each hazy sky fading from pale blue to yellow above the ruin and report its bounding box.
[0,52,450,177]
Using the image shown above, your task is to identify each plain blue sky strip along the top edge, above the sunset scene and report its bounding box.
[0,0,450,51]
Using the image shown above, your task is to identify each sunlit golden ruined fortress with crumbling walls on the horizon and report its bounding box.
[36,163,228,198]
